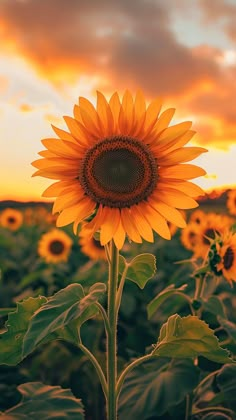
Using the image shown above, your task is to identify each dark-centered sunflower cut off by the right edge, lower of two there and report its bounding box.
[209,232,236,284]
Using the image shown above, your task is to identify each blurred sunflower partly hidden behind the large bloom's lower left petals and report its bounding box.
[79,226,107,260]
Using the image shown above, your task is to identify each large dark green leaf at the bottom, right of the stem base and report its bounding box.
[119,358,199,420]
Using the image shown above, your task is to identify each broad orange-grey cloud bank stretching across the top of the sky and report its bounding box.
[0,0,236,148]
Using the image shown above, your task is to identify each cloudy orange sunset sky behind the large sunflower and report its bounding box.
[0,0,236,201]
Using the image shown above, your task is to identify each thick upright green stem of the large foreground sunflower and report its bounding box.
[107,240,119,420]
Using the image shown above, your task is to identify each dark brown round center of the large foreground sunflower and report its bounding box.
[79,136,158,208]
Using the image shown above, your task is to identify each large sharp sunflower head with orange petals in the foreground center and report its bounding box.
[33,91,206,249]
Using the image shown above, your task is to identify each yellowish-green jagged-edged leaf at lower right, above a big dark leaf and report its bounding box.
[152,314,233,363]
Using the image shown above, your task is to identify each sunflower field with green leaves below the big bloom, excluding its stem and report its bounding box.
[0,190,236,420]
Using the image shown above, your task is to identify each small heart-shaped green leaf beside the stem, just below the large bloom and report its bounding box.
[126,254,156,289]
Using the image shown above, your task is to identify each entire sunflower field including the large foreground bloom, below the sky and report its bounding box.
[0,90,236,420]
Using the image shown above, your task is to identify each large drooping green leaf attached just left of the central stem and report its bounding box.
[23,283,106,356]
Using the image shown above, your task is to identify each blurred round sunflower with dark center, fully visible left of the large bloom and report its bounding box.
[38,229,72,263]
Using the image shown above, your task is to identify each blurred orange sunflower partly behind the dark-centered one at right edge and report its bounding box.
[194,213,232,258]
